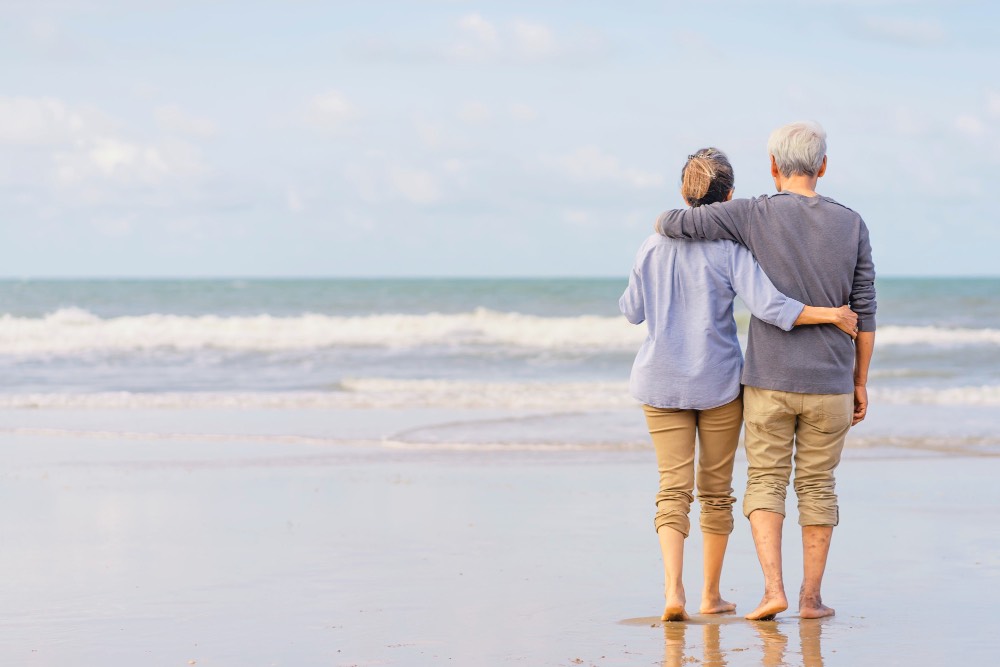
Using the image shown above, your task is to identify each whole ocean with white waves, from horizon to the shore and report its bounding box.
[0,278,1000,453]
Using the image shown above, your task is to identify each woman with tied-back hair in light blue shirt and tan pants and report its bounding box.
[619,148,857,621]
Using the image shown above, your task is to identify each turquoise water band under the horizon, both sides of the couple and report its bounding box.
[0,277,1000,328]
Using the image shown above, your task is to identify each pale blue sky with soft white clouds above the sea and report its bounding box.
[0,0,1000,278]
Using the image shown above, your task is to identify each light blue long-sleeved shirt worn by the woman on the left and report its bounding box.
[618,234,803,410]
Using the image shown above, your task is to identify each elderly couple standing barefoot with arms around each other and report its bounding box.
[619,122,875,621]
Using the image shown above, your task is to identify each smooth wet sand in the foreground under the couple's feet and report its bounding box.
[0,412,1000,667]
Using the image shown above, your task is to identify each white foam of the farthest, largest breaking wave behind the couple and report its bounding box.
[0,308,1000,355]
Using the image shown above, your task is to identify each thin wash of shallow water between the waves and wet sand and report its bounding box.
[0,405,1000,460]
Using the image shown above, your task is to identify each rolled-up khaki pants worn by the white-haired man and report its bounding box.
[743,387,854,526]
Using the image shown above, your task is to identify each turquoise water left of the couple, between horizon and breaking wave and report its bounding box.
[0,278,627,317]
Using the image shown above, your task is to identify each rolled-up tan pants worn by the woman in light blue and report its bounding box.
[643,398,743,537]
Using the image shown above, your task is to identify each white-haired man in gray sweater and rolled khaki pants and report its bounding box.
[656,122,875,620]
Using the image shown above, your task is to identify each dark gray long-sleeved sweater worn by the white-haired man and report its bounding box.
[656,192,875,394]
